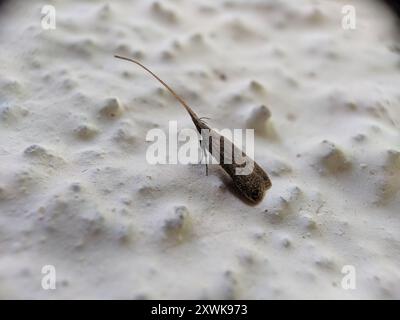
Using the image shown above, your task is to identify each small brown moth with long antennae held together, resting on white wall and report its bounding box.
[115,55,272,204]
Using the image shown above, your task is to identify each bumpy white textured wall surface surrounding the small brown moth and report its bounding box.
[0,0,400,299]
